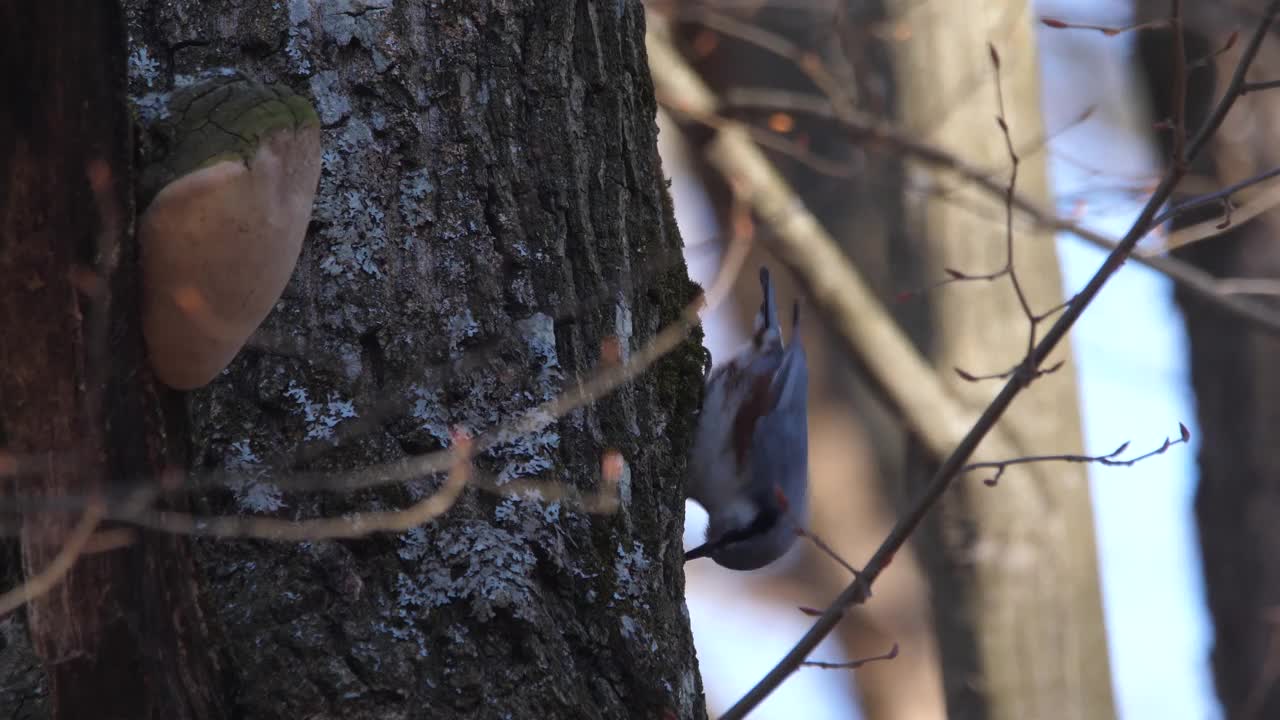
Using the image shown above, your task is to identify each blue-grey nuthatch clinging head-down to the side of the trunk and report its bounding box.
[685,268,809,570]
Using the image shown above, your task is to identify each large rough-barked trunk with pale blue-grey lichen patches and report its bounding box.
[0,0,704,720]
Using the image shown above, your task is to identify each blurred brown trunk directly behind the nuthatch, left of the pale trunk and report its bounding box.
[655,0,943,720]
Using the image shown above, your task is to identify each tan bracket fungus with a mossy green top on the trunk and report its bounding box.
[138,73,320,389]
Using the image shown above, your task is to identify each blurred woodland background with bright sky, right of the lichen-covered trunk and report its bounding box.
[650,0,1280,720]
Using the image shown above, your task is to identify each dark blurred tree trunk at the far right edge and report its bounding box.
[1137,0,1280,720]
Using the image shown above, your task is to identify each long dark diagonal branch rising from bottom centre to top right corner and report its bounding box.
[721,0,1280,720]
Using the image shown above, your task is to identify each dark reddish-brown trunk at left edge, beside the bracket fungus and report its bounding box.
[0,3,224,720]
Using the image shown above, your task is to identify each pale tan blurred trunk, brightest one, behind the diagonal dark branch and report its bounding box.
[890,0,1115,720]
